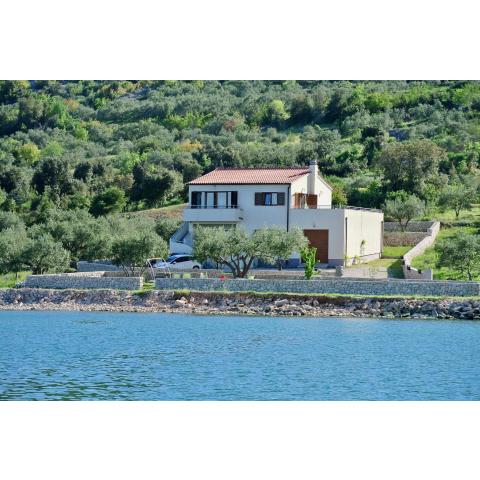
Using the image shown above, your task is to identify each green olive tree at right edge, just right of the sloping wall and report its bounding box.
[435,233,480,281]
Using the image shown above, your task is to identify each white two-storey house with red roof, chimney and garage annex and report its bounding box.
[170,162,383,266]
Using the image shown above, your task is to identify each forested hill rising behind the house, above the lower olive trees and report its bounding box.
[0,81,480,218]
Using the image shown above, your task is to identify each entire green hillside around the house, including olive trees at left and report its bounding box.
[0,81,480,283]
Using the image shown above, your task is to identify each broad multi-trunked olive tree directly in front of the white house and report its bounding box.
[193,227,307,278]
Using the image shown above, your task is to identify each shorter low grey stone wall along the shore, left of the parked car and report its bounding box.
[25,272,143,290]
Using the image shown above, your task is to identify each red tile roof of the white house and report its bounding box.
[189,167,309,185]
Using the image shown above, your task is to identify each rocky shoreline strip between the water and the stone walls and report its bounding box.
[0,288,480,320]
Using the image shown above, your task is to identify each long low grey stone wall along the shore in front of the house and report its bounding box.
[155,278,480,297]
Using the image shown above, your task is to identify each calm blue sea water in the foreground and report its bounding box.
[0,312,480,400]
